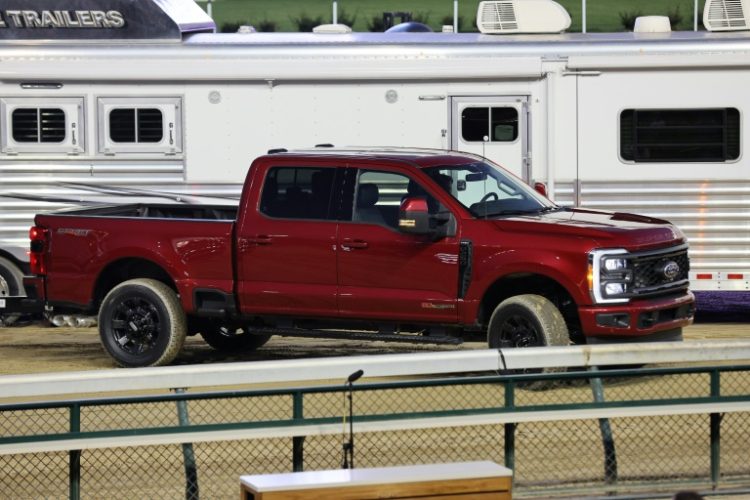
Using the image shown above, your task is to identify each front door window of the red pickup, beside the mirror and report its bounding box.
[352,170,440,229]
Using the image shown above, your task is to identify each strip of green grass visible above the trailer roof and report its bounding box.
[198,0,703,32]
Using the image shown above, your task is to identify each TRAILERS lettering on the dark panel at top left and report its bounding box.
[0,10,125,29]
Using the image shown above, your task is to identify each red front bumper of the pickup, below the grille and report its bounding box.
[578,292,695,341]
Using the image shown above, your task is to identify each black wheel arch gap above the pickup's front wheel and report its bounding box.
[477,272,583,343]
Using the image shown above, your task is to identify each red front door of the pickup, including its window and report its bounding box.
[337,168,459,323]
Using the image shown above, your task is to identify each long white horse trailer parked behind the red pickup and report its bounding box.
[0,0,750,320]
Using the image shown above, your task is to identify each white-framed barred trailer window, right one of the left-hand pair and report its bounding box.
[97,97,183,155]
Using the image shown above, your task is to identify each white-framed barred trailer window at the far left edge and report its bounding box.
[0,97,85,154]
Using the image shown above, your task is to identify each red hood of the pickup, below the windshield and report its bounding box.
[494,208,685,251]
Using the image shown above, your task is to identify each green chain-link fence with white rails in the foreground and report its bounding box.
[0,341,750,498]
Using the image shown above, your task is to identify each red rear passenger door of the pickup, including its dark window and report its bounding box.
[237,159,338,316]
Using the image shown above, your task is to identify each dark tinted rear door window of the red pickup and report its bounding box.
[260,167,336,219]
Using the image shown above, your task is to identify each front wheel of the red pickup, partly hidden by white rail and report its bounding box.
[487,295,570,373]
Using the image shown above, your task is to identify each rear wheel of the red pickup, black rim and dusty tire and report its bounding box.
[99,279,187,367]
